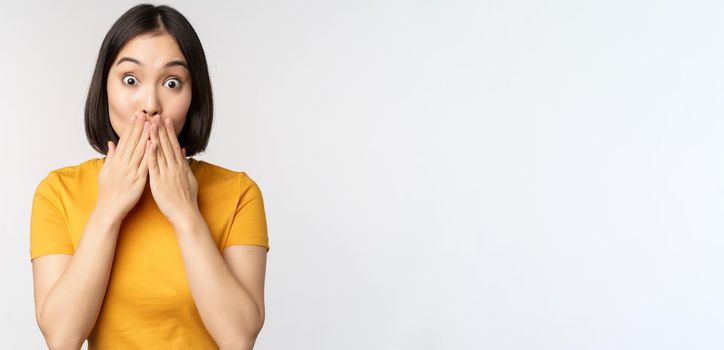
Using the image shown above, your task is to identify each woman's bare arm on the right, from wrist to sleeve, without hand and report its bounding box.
[174,212,266,349]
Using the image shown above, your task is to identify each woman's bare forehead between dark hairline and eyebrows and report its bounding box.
[113,33,185,67]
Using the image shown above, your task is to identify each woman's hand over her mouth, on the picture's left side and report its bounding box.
[96,113,151,220]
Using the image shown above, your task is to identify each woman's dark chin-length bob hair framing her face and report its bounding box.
[85,4,214,157]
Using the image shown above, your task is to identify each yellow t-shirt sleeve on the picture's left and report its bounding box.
[30,174,75,261]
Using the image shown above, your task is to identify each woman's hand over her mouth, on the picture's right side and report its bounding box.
[148,116,199,226]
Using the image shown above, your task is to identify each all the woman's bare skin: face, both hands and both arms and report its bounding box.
[33,34,266,349]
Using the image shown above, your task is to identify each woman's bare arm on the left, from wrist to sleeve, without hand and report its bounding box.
[33,207,121,349]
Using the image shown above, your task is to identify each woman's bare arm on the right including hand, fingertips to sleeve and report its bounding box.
[148,116,266,349]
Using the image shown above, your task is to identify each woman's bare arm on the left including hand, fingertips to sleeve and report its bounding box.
[33,114,154,349]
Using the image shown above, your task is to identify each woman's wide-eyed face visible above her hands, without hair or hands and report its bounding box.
[107,33,191,136]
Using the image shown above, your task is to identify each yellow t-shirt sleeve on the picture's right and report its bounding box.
[224,173,269,252]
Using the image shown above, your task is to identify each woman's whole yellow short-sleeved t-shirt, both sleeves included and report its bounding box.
[30,158,269,350]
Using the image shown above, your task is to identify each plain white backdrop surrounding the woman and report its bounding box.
[0,0,724,350]
